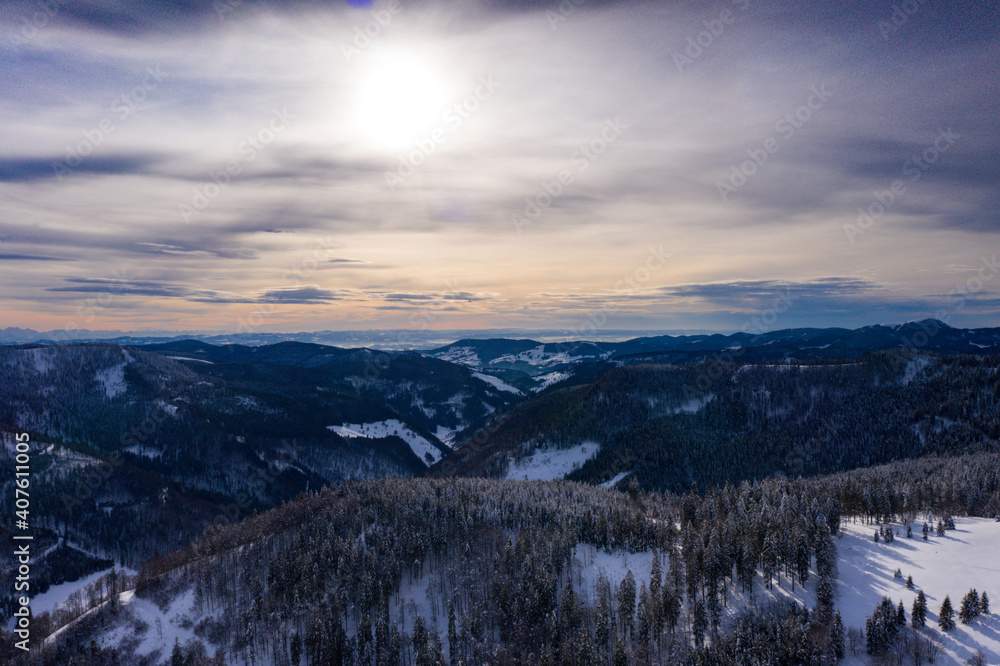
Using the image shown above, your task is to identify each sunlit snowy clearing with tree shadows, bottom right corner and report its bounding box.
[837,518,1000,664]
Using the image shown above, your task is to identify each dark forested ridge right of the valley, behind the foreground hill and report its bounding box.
[442,351,1000,492]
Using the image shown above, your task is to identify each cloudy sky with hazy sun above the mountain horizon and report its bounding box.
[0,0,1000,331]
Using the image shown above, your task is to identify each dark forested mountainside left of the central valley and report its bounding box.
[0,342,522,606]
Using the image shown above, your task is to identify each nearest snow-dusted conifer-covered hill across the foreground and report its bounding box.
[15,454,1000,666]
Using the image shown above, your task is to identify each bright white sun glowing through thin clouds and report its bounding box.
[357,51,451,150]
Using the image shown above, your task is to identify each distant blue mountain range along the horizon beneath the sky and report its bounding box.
[0,319,1000,360]
